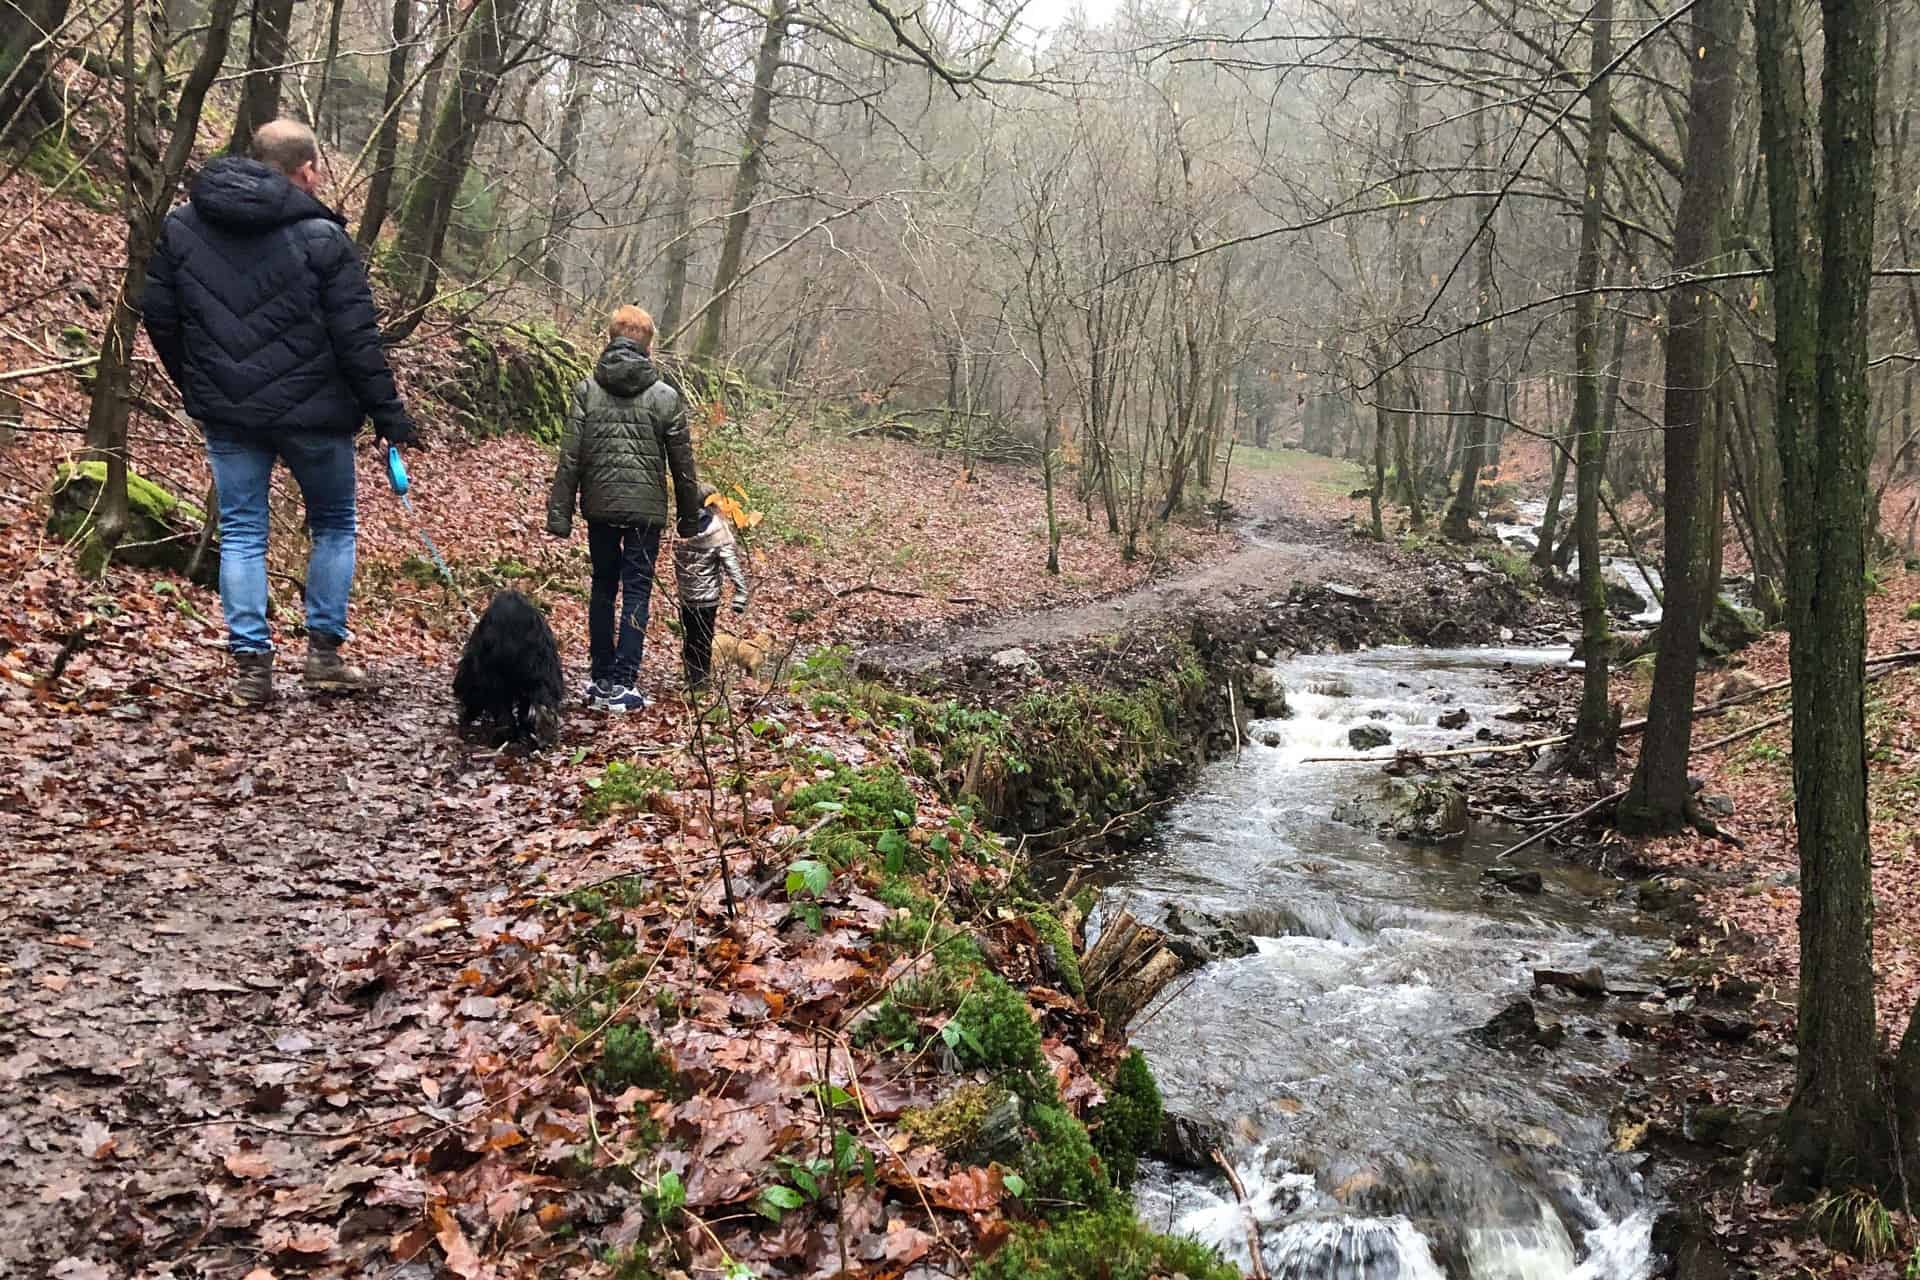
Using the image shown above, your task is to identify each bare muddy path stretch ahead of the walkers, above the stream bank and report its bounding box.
[862,510,1392,672]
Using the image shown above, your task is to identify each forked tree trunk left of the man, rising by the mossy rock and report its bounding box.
[86,0,234,553]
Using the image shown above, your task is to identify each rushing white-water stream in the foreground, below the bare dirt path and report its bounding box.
[1102,649,1657,1280]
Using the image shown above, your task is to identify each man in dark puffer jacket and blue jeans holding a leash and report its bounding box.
[140,121,417,706]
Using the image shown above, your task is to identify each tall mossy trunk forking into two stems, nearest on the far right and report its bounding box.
[1755,0,1885,1190]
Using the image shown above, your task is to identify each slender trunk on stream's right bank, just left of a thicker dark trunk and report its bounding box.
[1572,0,1619,771]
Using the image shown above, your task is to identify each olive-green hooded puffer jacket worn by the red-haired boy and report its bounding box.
[547,338,701,537]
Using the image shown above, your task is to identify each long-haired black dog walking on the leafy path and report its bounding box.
[453,591,566,743]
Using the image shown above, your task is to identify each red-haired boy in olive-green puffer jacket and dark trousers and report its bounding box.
[547,307,703,712]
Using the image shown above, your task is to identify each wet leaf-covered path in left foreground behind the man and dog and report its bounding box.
[0,658,564,1278]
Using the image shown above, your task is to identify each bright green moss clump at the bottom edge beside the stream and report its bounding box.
[973,1209,1240,1280]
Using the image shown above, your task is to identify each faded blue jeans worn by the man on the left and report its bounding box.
[207,432,355,652]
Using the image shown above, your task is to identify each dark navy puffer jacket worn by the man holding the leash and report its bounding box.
[140,155,411,436]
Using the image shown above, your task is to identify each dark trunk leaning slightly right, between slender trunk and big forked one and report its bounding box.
[1615,0,1740,833]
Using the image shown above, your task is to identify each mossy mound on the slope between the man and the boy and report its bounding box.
[447,324,591,445]
